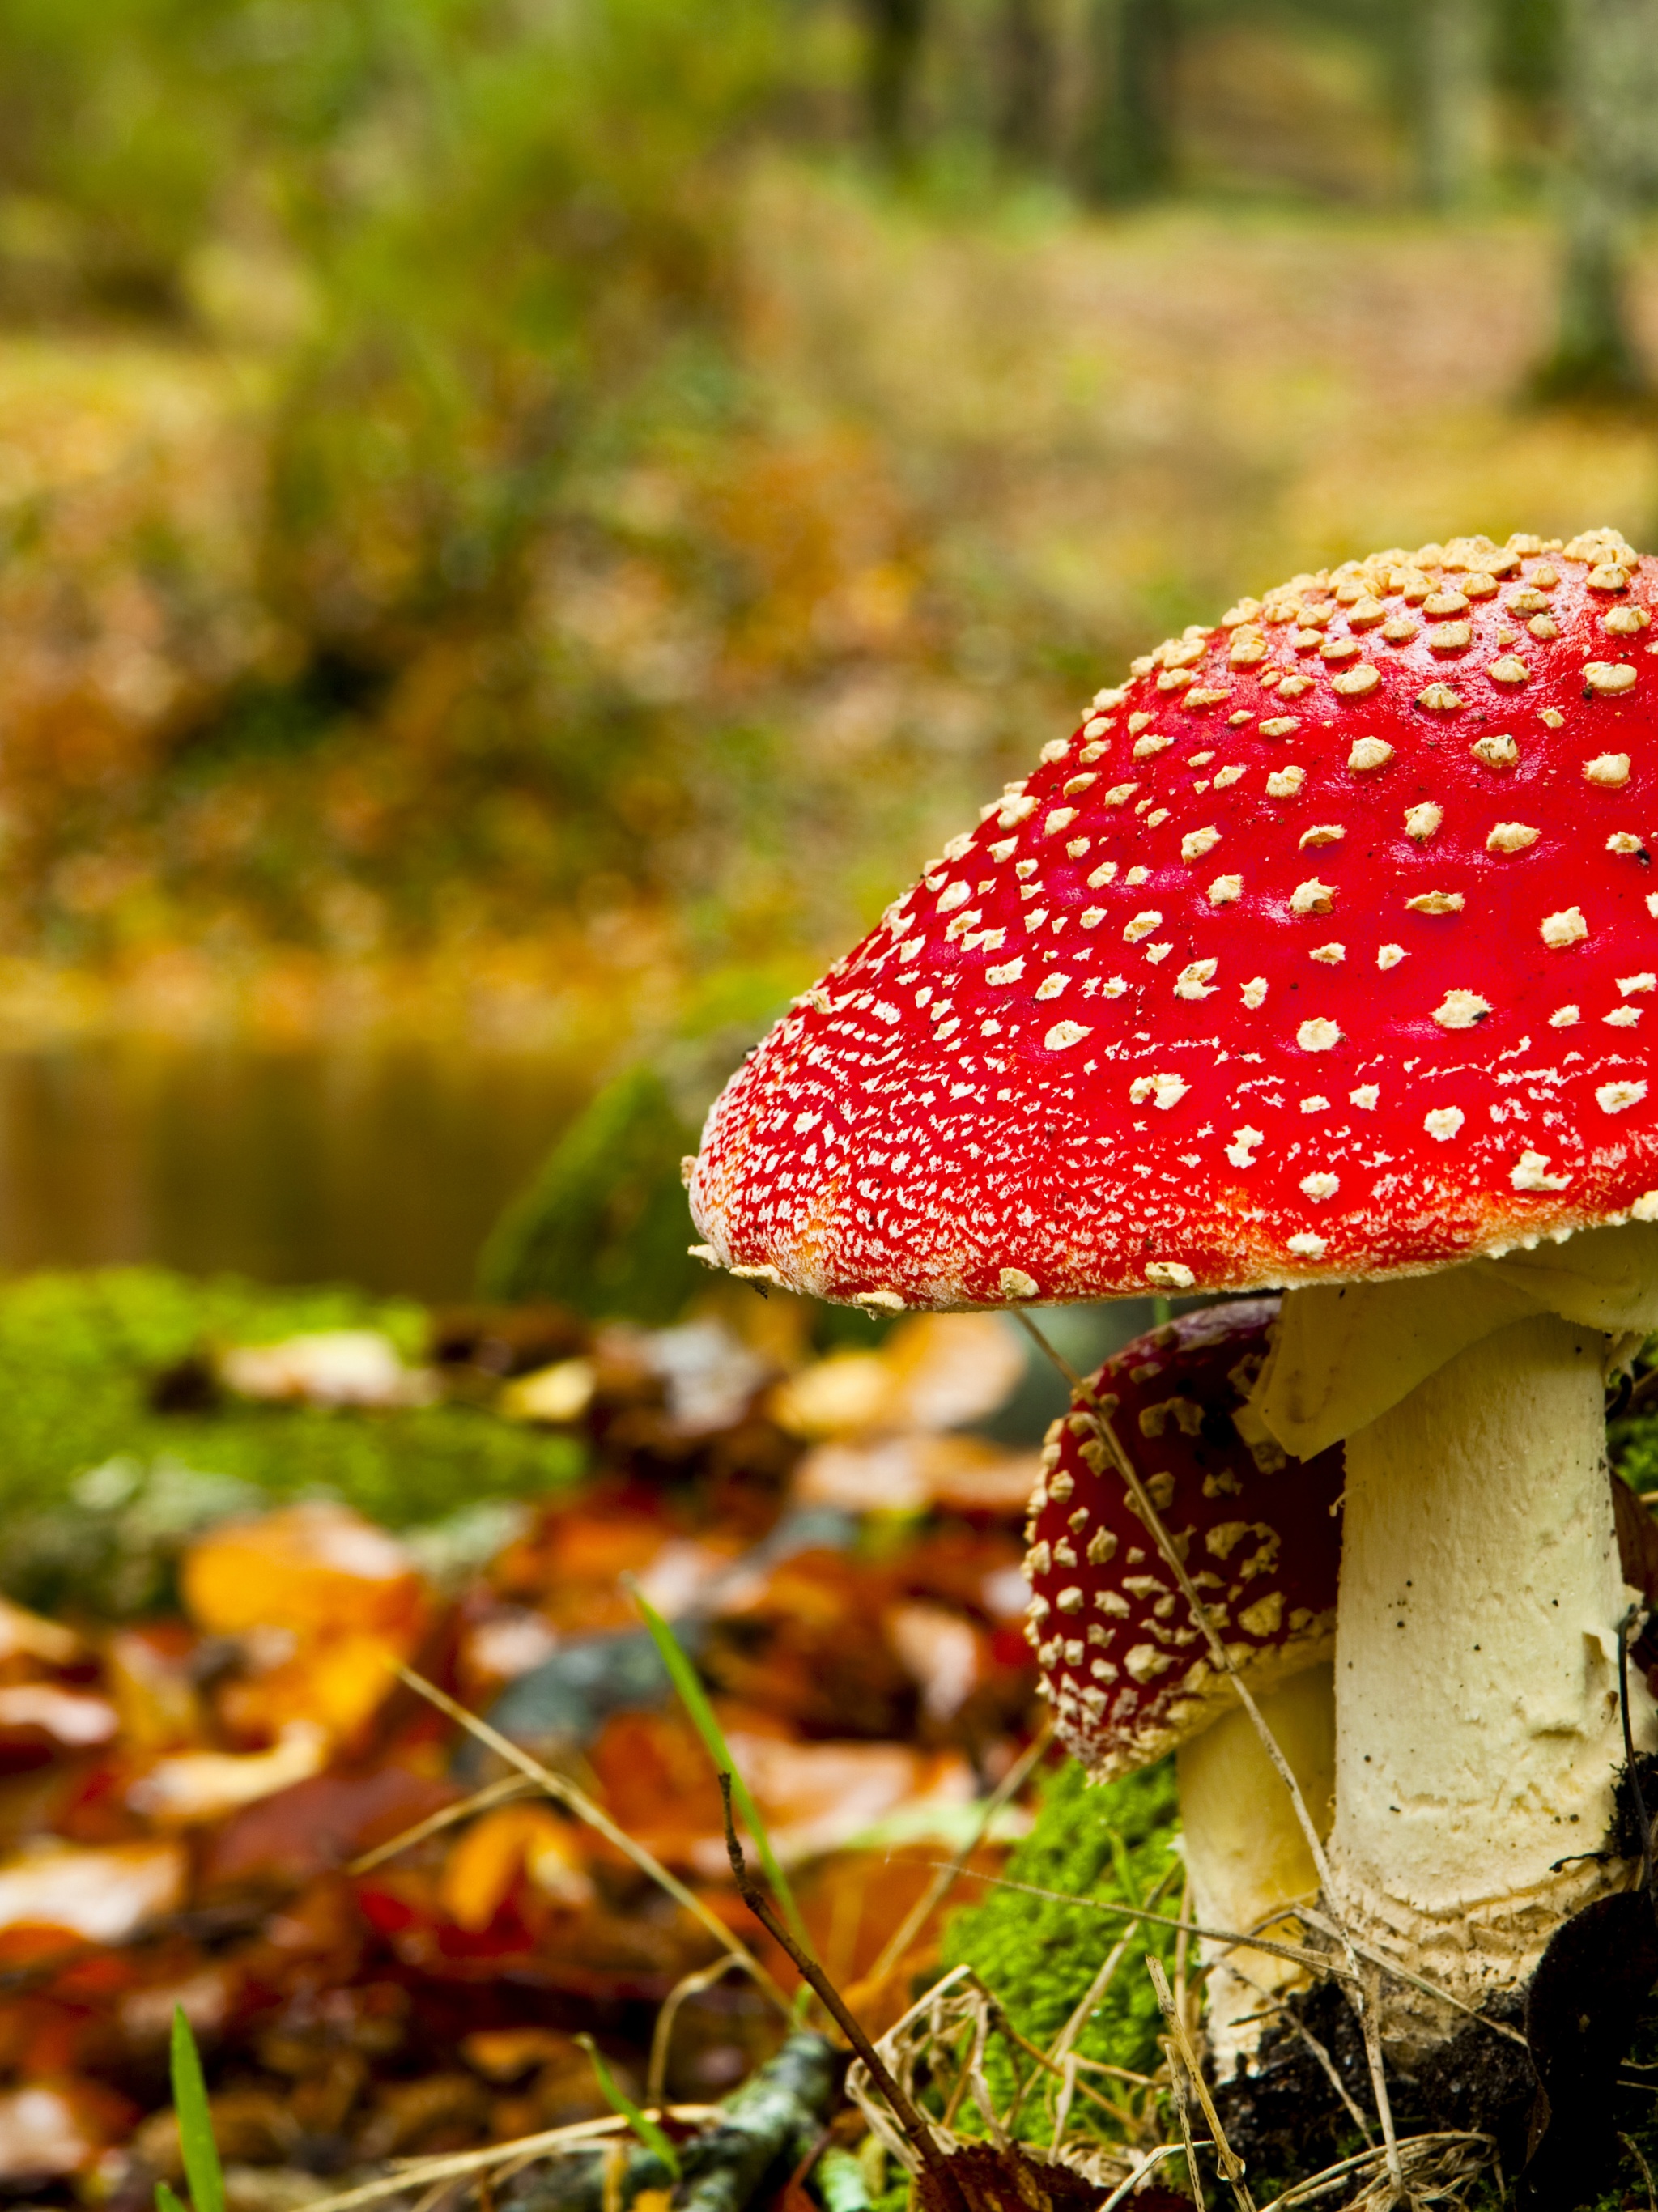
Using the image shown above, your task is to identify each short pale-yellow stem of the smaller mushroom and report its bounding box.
[1176,1661,1335,2082]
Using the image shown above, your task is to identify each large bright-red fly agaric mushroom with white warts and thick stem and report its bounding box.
[690,531,1658,2055]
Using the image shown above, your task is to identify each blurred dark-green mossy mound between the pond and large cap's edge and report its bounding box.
[478,1066,705,1323]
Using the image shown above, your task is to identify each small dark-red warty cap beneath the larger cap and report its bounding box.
[1026,1299,1342,1780]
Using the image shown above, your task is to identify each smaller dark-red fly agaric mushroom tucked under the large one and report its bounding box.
[1026,1299,1342,2077]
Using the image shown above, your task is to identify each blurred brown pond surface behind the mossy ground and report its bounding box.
[0,1042,588,1299]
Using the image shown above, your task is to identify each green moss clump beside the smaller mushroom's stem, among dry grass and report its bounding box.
[944,1761,1180,2134]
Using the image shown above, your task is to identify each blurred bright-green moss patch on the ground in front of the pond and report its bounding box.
[0,1267,581,1610]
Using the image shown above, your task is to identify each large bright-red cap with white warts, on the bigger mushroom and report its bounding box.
[692,531,1658,1309]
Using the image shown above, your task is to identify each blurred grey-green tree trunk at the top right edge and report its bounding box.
[1534,0,1658,400]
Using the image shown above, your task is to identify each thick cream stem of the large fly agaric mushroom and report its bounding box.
[1329,1317,1627,2059]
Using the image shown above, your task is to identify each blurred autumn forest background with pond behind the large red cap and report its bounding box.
[0,0,1658,1294]
